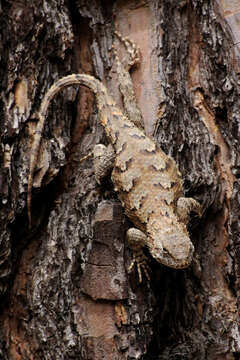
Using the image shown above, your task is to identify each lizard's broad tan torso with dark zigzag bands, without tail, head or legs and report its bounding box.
[112,122,184,232]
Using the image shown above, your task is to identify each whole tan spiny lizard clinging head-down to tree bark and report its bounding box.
[27,33,201,282]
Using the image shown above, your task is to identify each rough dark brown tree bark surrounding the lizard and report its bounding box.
[0,0,240,360]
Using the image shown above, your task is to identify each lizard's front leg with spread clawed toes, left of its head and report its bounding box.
[127,228,151,283]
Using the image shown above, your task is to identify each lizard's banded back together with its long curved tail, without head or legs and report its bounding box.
[28,74,183,230]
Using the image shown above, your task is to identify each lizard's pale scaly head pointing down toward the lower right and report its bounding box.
[148,223,194,269]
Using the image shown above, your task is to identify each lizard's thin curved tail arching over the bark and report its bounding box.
[27,74,106,228]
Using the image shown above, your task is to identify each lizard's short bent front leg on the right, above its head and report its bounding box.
[177,197,202,224]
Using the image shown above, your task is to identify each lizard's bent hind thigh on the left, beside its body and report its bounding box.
[93,144,116,184]
